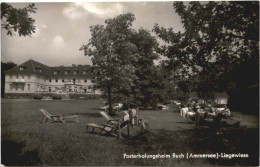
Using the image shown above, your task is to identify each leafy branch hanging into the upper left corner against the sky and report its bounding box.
[1,3,37,36]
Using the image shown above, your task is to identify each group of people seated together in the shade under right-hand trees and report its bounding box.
[180,102,231,127]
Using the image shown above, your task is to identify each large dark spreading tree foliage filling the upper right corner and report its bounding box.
[154,2,259,105]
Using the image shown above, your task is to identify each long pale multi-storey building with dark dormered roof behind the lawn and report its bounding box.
[5,60,100,94]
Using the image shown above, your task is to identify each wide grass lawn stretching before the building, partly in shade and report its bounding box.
[1,99,259,166]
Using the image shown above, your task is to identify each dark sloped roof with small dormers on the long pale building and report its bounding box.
[5,59,91,78]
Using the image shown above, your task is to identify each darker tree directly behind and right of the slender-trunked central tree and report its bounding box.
[128,28,163,108]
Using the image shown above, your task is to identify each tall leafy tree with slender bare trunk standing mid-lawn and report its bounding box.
[80,13,138,114]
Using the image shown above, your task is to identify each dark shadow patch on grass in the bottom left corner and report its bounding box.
[1,140,41,166]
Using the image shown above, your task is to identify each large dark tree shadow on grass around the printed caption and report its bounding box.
[125,129,259,166]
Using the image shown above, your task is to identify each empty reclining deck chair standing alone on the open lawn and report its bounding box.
[40,109,78,123]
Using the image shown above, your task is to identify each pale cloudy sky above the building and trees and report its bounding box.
[1,2,183,66]
